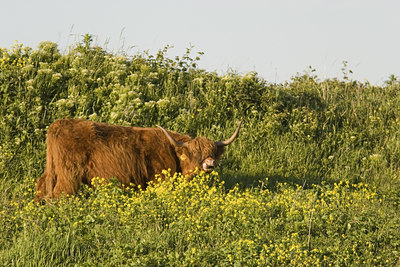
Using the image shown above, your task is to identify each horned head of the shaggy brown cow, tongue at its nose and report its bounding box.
[158,122,242,175]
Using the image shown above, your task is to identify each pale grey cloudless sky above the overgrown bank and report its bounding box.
[0,0,400,84]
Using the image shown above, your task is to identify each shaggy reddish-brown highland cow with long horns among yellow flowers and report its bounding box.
[36,119,240,200]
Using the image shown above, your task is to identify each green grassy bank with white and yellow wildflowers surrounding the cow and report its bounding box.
[0,35,400,266]
